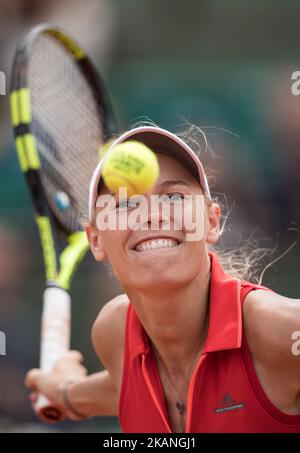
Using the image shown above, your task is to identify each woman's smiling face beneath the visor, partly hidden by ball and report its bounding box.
[86,153,220,290]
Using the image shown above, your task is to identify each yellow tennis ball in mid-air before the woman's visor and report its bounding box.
[102,141,159,197]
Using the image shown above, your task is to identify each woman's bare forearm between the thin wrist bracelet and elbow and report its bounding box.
[67,370,119,417]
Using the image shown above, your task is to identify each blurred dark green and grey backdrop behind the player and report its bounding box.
[0,0,300,432]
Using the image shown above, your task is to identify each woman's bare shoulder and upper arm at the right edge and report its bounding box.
[243,290,300,414]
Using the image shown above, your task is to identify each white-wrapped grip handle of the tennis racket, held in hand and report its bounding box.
[35,287,71,421]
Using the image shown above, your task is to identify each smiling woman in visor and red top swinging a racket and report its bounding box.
[26,126,300,433]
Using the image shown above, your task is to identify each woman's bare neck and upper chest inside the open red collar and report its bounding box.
[125,251,210,378]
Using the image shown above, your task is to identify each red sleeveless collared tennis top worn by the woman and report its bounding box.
[119,252,300,433]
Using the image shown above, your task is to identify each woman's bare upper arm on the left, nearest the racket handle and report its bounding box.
[92,294,129,389]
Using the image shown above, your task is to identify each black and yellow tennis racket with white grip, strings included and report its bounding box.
[10,24,116,421]
